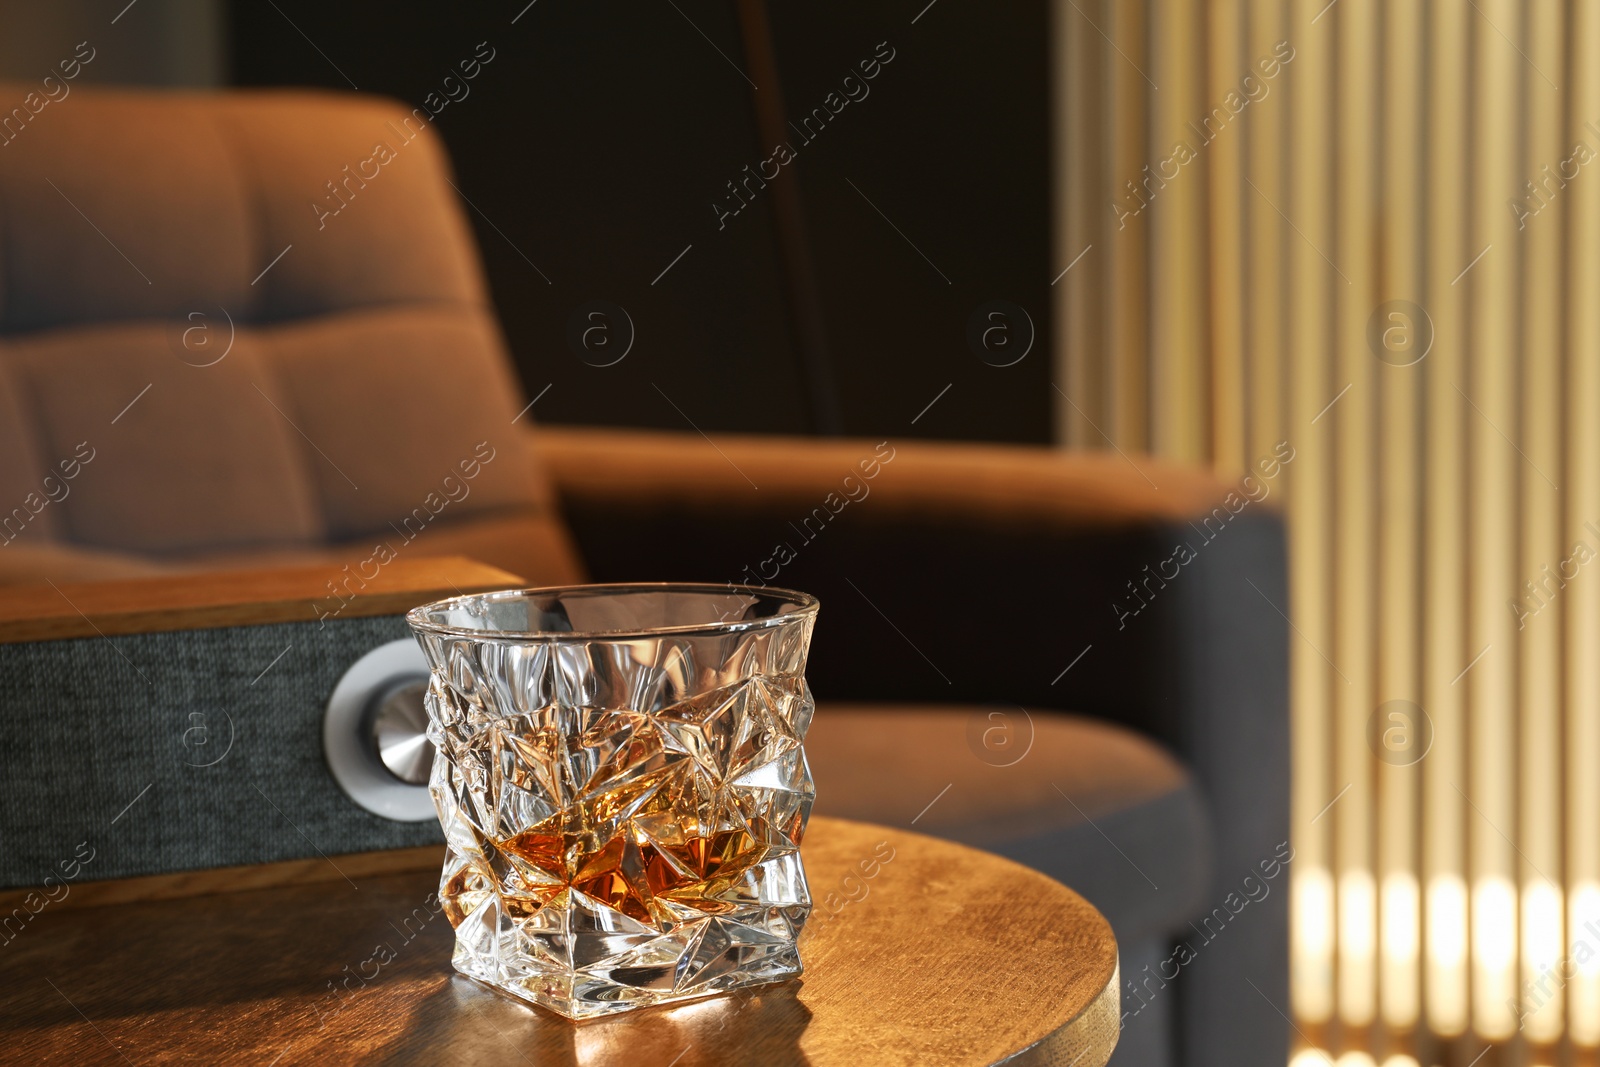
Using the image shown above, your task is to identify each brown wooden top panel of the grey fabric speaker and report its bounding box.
[0,557,523,645]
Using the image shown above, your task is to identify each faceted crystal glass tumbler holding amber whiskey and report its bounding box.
[406,585,818,1019]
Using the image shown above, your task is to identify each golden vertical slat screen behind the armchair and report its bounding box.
[1053,0,1600,1067]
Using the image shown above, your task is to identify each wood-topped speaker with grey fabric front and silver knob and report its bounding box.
[0,558,523,888]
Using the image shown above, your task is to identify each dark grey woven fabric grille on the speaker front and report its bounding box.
[0,616,443,888]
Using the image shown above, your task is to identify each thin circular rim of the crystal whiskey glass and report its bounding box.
[405,582,821,645]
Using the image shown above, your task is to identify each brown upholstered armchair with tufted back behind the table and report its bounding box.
[0,90,1288,1067]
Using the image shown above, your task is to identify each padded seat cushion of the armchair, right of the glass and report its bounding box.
[806,704,1211,944]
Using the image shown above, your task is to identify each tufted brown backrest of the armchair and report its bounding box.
[0,90,581,582]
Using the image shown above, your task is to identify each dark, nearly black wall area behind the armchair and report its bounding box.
[225,0,1051,442]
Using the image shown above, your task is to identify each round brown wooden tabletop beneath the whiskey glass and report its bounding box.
[0,817,1118,1067]
